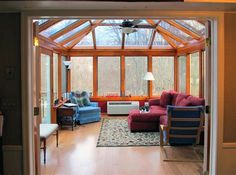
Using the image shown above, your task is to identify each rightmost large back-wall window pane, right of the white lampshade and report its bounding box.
[152,57,174,96]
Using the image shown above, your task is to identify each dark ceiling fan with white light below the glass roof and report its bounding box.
[120,19,142,35]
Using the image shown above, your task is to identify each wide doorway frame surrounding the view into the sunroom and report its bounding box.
[21,10,224,175]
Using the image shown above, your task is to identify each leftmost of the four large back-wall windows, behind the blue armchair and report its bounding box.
[71,57,93,92]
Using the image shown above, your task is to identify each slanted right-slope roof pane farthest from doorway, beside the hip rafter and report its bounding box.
[159,21,192,41]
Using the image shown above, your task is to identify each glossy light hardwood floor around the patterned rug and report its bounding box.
[41,116,202,175]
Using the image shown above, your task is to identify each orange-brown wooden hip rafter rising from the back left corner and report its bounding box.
[67,20,103,49]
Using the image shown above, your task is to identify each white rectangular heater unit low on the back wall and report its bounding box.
[107,101,139,115]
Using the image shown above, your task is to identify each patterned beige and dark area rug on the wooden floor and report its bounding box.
[97,118,160,147]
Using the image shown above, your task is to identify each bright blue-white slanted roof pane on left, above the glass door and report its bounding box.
[40,19,78,37]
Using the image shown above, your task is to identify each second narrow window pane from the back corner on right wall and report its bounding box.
[190,52,199,96]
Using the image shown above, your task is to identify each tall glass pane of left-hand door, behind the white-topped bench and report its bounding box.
[40,54,51,123]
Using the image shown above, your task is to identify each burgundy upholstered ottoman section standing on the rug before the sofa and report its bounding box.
[128,109,160,132]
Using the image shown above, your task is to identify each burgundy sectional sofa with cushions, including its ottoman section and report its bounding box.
[128,91,205,132]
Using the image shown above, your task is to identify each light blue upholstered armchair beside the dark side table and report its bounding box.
[70,93,101,124]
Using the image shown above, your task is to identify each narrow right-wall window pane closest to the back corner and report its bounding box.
[178,56,186,93]
